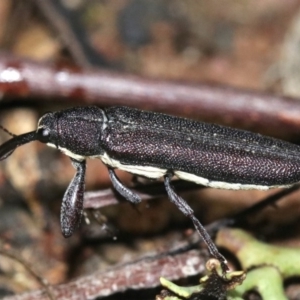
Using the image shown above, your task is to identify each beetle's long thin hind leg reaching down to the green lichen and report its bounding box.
[164,172,228,272]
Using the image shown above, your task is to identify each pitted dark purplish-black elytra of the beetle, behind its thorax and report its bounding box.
[102,107,300,185]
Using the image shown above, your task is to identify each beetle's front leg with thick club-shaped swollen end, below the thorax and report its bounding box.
[60,158,86,238]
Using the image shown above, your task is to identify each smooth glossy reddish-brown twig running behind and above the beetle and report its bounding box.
[0,55,300,139]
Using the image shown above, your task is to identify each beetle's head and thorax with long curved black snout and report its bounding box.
[0,107,107,160]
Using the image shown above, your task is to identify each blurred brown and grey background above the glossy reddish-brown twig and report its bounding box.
[0,0,300,91]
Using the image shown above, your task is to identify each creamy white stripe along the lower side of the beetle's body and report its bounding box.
[47,143,290,190]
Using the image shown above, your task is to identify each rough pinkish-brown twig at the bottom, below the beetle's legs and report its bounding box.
[4,250,208,300]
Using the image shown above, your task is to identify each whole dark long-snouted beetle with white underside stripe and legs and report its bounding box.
[0,106,300,271]
